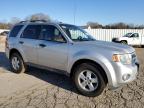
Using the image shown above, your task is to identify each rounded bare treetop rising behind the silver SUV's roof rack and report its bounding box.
[26,13,51,21]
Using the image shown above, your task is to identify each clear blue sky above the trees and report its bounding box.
[0,0,144,25]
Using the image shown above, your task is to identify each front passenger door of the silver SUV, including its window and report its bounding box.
[38,25,68,70]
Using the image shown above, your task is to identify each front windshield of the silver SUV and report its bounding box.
[60,24,95,41]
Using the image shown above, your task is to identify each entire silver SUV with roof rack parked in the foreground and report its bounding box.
[6,21,139,96]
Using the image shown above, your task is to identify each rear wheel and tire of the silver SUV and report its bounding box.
[10,53,27,74]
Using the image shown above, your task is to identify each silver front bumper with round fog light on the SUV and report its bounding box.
[110,62,140,89]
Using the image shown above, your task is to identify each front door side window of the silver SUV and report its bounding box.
[42,25,65,42]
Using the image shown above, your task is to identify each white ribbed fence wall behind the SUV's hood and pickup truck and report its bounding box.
[86,29,144,41]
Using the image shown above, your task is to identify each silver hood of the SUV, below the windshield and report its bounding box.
[75,41,135,54]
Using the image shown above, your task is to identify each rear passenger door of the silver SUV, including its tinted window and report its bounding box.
[19,25,41,64]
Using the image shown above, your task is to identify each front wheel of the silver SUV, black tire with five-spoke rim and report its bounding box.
[73,63,106,97]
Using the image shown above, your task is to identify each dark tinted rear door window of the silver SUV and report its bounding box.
[22,25,41,39]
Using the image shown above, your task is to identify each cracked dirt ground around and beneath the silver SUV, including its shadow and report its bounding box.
[0,42,144,108]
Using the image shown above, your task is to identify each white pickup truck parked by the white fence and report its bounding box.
[112,33,144,46]
